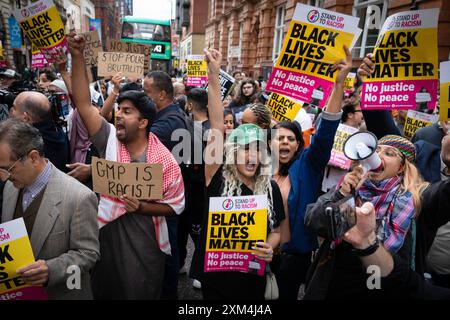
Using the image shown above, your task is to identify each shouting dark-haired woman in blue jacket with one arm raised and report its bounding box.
[271,47,352,300]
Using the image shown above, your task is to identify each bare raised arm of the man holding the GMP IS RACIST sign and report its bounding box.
[67,32,102,137]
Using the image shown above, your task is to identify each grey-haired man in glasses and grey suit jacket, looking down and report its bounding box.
[0,119,100,299]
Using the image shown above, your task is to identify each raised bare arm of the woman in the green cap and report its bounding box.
[205,49,224,186]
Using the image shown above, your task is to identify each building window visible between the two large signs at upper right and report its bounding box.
[353,0,388,58]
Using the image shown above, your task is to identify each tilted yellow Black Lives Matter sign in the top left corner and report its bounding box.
[14,0,67,63]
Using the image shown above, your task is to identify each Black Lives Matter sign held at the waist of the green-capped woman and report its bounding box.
[204,195,268,276]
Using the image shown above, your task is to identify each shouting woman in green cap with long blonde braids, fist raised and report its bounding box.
[194,49,284,300]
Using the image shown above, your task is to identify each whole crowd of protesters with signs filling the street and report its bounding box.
[0,0,450,301]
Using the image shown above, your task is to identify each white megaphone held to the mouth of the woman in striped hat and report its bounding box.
[343,131,383,173]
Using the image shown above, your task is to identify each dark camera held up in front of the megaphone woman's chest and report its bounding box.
[325,195,356,240]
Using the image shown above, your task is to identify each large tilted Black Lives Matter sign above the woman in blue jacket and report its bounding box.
[266,3,361,107]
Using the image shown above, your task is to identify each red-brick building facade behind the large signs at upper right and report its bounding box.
[205,0,450,79]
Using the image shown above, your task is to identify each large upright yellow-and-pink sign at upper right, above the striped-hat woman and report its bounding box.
[361,9,439,111]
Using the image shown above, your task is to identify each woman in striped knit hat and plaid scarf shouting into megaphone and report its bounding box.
[305,135,436,299]
